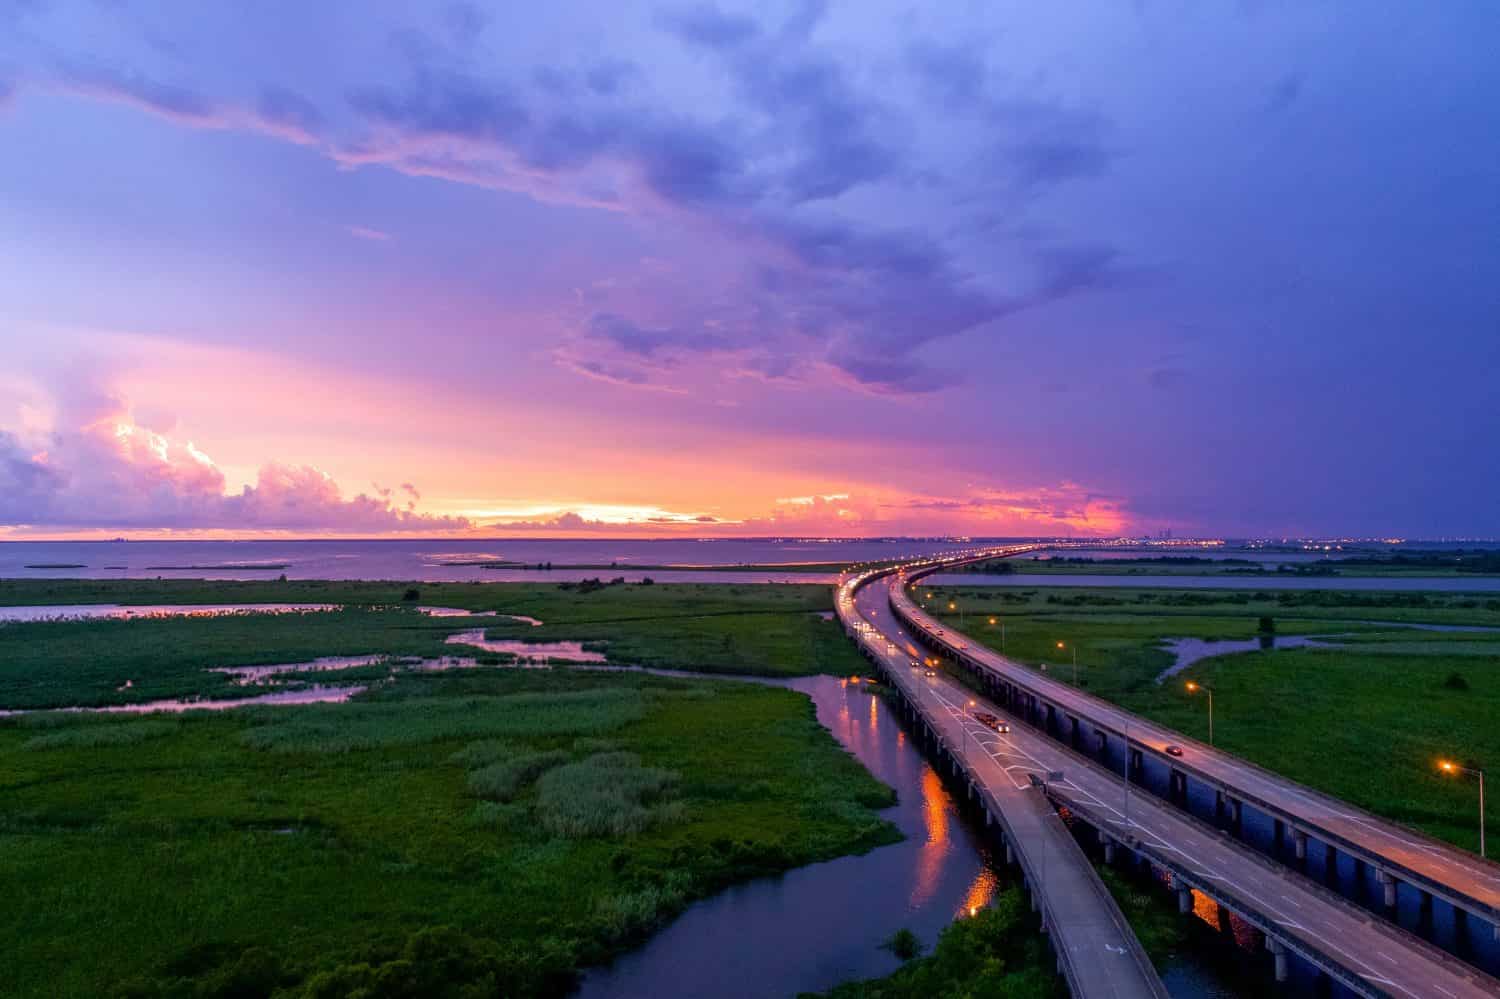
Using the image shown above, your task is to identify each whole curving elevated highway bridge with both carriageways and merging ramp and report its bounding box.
[837,548,1500,999]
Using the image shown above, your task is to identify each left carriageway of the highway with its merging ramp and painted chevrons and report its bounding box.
[839,552,1500,999]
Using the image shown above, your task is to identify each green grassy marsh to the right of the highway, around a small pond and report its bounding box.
[923,588,1500,849]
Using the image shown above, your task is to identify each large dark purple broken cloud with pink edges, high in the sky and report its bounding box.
[23,10,1116,395]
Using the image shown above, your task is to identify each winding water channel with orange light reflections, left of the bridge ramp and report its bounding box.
[581,677,999,999]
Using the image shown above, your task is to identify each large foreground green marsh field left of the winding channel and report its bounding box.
[0,671,896,996]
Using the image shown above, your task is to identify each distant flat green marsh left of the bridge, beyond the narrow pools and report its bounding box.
[0,579,863,708]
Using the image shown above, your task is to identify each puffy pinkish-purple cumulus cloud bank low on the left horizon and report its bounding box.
[0,379,470,534]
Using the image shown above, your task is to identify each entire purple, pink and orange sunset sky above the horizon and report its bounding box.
[0,0,1500,539]
